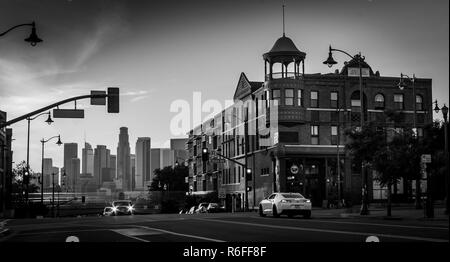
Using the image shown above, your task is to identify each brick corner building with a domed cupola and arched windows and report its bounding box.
[187,35,432,210]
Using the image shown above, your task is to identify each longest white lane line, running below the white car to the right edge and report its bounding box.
[193,218,448,242]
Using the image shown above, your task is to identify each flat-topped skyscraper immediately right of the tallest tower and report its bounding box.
[135,137,152,190]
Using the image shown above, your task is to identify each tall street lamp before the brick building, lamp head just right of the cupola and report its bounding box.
[323,45,369,215]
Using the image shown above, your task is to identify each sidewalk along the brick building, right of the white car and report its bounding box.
[312,205,449,221]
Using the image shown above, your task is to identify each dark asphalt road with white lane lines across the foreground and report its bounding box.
[0,213,449,243]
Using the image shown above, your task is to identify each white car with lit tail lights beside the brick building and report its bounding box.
[259,193,311,218]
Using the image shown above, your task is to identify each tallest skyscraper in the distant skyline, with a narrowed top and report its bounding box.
[117,127,132,191]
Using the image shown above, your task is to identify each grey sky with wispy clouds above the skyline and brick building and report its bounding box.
[0,0,449,171]
